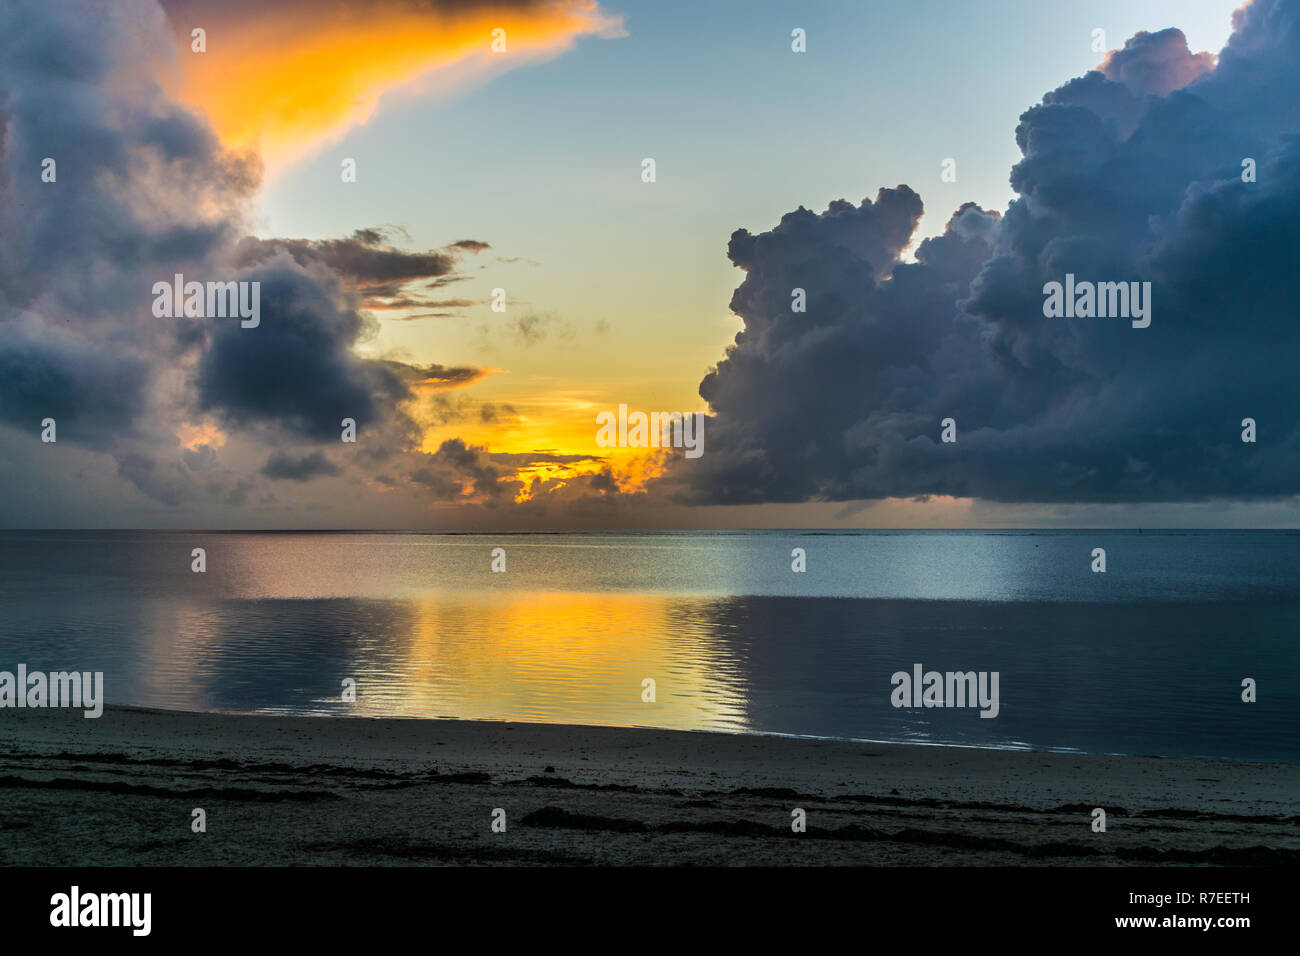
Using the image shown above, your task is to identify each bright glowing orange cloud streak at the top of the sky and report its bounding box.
[164,0,623,169]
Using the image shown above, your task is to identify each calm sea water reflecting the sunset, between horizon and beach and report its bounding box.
[0,531,1300,762]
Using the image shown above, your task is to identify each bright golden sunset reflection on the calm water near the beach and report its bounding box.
[335,592,749,731]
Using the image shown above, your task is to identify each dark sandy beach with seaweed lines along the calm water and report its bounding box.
[0,706,1300,866]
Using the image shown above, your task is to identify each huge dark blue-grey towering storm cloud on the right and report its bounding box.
[673,0,1300,502]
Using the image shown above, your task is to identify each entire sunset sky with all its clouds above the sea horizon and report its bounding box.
[0,0,1300,529]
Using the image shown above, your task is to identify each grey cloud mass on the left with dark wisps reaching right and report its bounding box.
[0,0,509,507]
